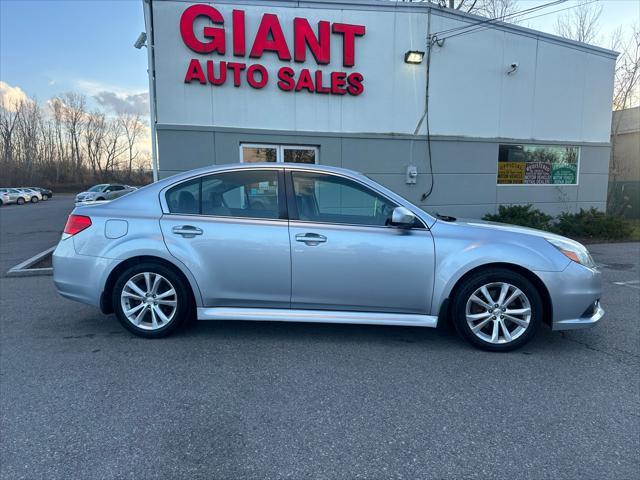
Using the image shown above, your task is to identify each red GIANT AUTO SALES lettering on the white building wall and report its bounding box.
[180,4,366,96]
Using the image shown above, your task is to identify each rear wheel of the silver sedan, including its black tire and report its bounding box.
[111,262,193,338]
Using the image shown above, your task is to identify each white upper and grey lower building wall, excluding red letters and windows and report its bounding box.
[147,0,615,217]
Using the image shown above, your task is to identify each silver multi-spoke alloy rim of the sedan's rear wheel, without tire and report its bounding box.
[120,272,178,331]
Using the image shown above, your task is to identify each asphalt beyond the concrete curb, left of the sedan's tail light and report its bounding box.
[0,195,74,276]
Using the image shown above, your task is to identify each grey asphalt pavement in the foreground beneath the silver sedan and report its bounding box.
[0,204,640,479]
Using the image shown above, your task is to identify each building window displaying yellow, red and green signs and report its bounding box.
[498,145,580,185]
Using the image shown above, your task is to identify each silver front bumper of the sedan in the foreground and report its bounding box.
[536,262,604,330]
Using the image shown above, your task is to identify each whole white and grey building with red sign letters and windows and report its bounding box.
[144,0,616,217]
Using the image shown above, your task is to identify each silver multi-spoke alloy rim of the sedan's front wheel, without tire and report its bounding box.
[466,282,531,344]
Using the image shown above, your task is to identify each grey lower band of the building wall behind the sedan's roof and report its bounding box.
[158,126,609,218]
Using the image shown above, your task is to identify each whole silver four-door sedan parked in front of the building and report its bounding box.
[53,163,604,351]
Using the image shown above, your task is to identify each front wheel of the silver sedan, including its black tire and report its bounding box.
[452,268,544,352]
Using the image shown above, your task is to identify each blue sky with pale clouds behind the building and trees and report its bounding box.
[0,0,640,115]
